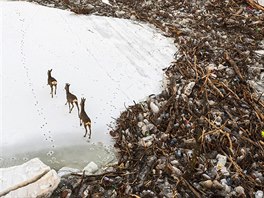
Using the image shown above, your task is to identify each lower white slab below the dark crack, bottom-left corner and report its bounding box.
[4,170,60,198]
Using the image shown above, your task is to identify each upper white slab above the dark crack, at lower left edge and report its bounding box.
[0,158,51,197]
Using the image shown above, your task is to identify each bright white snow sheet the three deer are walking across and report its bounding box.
[0,1,176,167]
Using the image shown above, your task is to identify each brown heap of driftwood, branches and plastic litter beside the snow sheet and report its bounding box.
[27,0,264,197]
